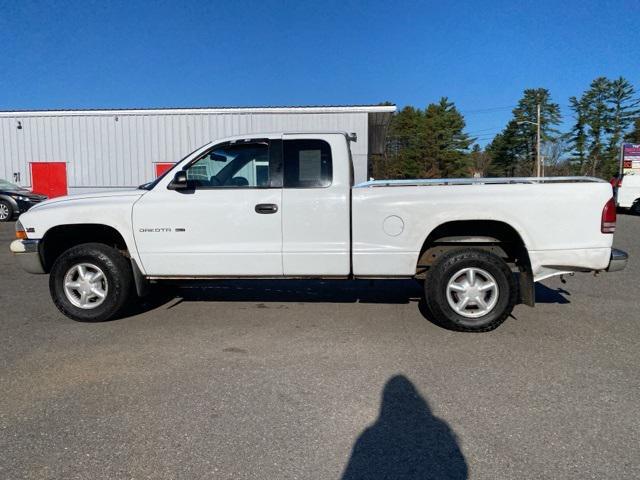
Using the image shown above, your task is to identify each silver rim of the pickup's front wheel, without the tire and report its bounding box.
[64,263,109,310]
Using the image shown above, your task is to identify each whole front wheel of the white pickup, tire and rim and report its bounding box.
[49,243,133,322]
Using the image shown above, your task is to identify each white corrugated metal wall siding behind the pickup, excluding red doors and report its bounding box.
[0,112,369,193]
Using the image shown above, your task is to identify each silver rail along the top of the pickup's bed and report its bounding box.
[354,177,606,188]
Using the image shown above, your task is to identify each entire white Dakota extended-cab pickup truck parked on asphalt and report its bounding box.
[11,132,627,331]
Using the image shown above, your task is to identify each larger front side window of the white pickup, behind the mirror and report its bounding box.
[186,142,270,188]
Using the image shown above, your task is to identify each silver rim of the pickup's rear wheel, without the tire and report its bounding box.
[446,267,500,318]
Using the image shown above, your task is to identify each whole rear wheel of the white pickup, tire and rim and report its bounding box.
[425,248,518,332]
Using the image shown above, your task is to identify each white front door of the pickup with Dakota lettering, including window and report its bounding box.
[133,140,283,277]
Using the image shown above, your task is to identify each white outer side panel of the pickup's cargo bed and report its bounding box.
[352,177,612,281]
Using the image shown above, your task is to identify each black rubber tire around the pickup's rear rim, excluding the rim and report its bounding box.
[425,248,518,332]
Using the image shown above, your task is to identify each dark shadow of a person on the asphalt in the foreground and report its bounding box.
[342,375,468,480]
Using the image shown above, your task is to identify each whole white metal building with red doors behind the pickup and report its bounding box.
[0,105,395,196]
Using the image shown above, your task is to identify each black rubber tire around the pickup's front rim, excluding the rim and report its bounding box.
[49,243,134,322]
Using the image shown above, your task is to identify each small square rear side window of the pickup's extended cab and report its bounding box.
[283,140,333,188]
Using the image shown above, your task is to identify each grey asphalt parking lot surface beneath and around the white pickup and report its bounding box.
[0,215,640,479]
